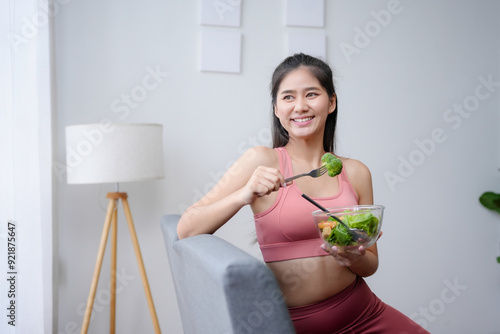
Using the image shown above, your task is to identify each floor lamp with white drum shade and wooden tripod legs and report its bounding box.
[66,122,164,334]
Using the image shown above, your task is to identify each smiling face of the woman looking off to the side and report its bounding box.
[274,67,336,140]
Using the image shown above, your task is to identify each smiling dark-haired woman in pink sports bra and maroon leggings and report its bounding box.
[177,54,426,334]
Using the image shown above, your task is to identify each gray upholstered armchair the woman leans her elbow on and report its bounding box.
[161,215,295,334]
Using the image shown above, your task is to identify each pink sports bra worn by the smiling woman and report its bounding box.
[254,147,358,262]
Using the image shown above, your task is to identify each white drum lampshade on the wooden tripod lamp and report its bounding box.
[66,122,164,184]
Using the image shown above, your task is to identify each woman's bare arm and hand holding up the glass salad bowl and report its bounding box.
[324,159,378,277]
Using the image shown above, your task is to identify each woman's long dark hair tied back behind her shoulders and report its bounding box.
[271,53,338,153]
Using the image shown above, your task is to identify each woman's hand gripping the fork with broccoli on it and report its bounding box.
[240,166,285,204]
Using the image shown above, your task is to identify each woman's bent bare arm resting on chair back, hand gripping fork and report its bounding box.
[177,147,284,239]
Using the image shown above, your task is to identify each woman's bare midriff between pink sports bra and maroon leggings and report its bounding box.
[267,256,356,307]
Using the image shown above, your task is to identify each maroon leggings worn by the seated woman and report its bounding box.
[288,277,429,334]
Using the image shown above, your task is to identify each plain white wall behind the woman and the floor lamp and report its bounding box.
[55,0,500,334]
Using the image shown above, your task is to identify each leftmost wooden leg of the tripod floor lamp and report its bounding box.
[81,199,116,334]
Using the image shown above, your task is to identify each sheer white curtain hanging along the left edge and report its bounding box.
[0,0,57,334]
